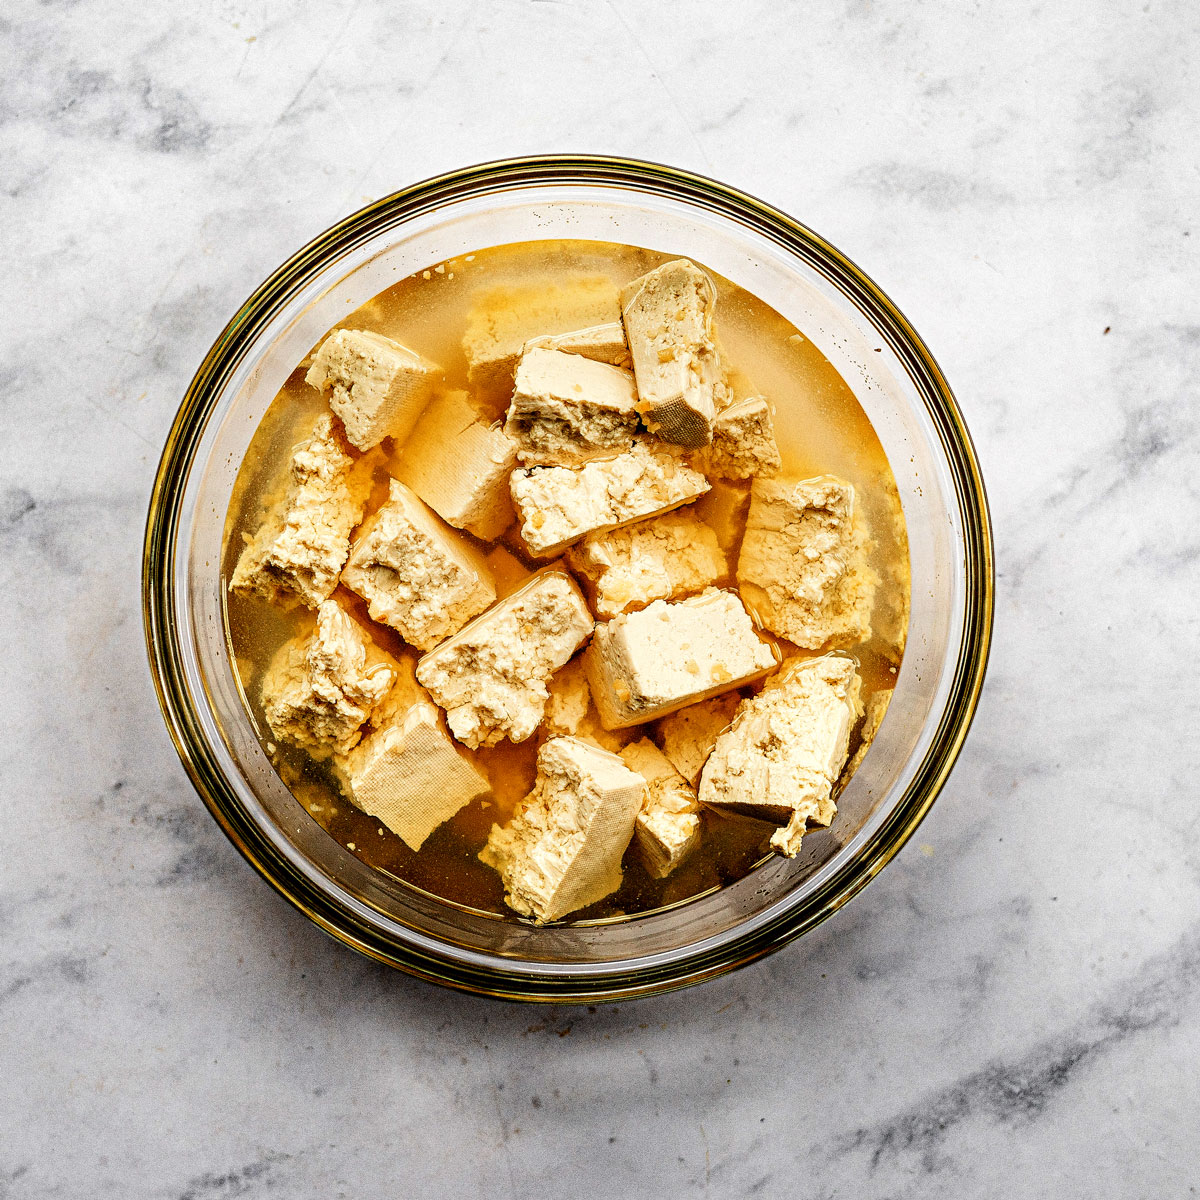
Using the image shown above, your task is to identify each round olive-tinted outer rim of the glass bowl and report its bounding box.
[142,154,995,1003]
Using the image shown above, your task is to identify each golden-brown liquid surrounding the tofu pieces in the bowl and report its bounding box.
[222,241,908,922]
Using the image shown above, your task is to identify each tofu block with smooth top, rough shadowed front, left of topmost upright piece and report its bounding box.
[504,349,638,467]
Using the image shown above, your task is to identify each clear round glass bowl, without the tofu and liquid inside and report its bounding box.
[143,155,994,1001]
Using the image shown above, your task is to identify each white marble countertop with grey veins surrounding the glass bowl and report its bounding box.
[0,0,1200,1200]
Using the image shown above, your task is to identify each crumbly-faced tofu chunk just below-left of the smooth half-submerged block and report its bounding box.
[342,479,496,650]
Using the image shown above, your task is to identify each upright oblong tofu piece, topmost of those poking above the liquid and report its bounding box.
[620,258,727,446]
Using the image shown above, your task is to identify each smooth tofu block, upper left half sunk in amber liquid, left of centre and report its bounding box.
[391,391,517,541]
